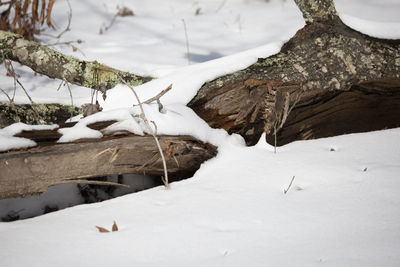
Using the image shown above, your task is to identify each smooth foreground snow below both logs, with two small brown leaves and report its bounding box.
[0,129,400,266]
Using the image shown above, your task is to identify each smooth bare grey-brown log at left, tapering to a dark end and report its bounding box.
[0,133,217,199]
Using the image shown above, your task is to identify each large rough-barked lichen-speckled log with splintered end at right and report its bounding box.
[188,0,400,145]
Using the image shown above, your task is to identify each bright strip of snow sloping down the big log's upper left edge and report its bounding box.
[99,42,283,110]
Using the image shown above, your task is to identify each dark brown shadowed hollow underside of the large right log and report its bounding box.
[267,79,400,146]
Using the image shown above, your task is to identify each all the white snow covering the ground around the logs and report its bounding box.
[0,0,400,266]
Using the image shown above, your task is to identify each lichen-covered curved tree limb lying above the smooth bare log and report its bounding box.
[0,31,151,91]
